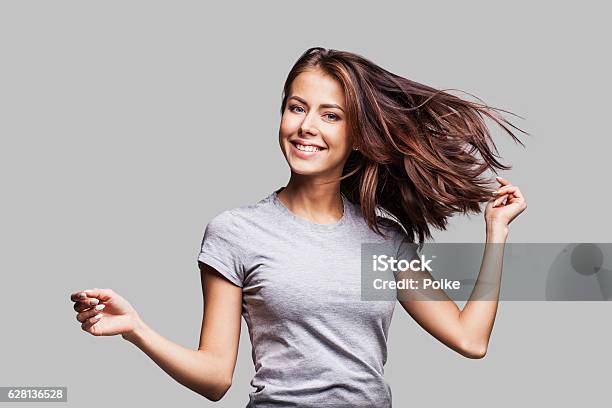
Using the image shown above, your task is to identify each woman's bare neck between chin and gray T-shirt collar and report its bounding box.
[278,173,344,224]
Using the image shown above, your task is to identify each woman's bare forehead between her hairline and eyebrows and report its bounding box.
[289,69,344,106]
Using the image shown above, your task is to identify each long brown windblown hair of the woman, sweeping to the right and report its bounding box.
[281,47,528,246]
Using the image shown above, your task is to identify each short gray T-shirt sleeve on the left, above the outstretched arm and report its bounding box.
[198,210,245,287]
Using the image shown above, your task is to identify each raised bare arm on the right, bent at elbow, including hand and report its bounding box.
[398,179,527,358]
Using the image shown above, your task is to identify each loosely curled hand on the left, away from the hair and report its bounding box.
[70,288,140,338]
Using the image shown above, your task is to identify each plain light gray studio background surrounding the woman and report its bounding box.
[0,1,612,407]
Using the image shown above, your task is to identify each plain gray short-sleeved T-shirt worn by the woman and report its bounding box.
[198,188,413,408]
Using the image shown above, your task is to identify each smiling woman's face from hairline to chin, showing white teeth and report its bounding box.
[279,69,352,177]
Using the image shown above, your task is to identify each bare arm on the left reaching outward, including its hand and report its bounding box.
[73,264,242,401]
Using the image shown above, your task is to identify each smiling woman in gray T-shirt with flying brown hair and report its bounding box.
[71,47,526,407]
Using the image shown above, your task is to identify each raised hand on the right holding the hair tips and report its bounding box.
[485,177,527,226]
